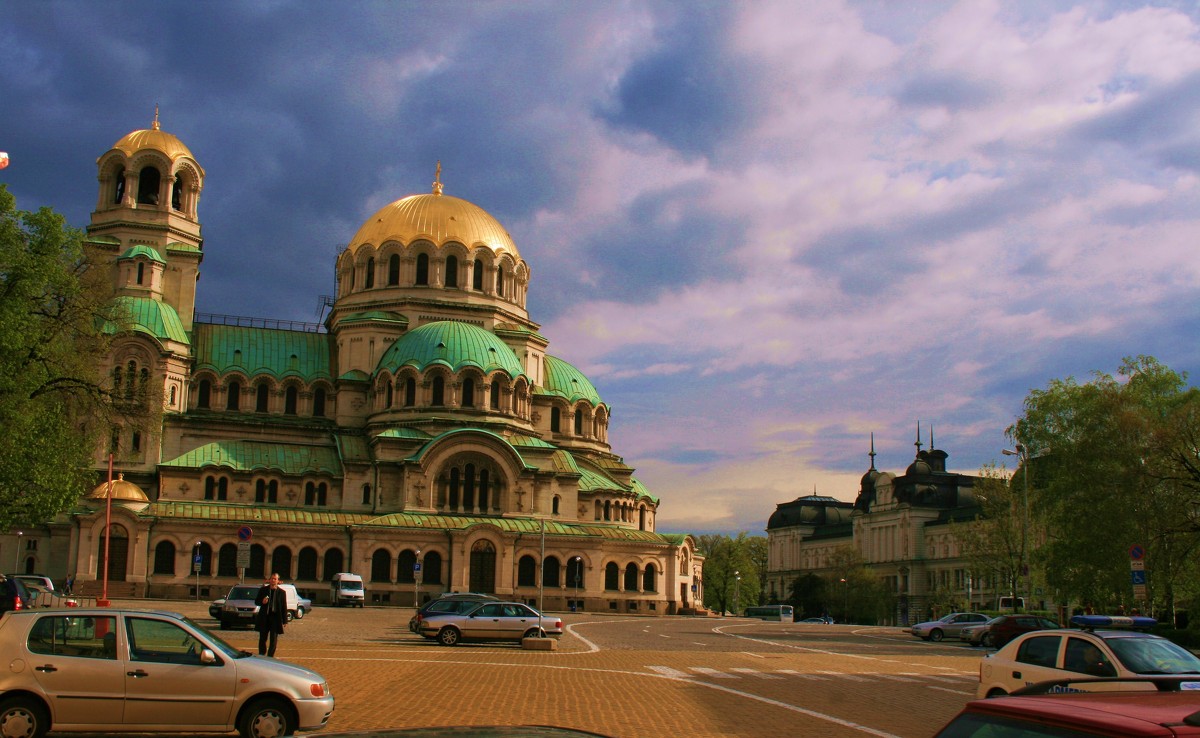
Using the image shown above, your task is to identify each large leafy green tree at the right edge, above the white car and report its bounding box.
[1007,356,1200,611]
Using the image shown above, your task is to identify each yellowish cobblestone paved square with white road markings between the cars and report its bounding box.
[121,601,982,738]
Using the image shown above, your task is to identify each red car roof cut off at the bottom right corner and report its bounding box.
[935,677,1200,738]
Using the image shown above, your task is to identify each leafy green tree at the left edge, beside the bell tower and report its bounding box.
[0,185,136,530]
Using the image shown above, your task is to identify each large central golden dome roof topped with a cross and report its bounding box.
[349,163,521,259]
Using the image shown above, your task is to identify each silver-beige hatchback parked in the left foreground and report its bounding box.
[0,607,334,738]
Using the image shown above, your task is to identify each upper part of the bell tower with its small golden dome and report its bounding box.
[86,107,204,331]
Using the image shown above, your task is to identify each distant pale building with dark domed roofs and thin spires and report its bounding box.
[767,434,995,624]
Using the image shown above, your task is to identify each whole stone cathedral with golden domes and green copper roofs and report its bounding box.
[14,113,702,614]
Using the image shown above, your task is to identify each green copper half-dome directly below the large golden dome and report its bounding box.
[377,320,524,378]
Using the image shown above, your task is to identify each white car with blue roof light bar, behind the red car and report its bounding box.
[977,616,1200,697]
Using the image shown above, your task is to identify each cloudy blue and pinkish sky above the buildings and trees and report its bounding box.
[0,0,1200,533]
